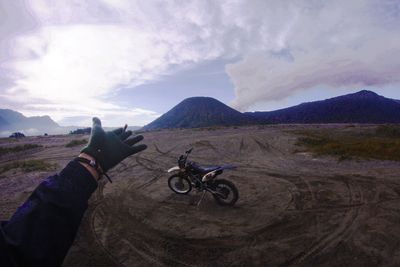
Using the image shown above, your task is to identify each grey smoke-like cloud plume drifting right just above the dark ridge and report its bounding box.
[226,36,400,110]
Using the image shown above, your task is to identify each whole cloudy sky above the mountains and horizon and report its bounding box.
[0,0,400,127]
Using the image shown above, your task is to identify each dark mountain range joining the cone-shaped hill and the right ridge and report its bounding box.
[142,90,400,130]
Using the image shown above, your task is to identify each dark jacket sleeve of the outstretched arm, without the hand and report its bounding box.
[0,161,97,266]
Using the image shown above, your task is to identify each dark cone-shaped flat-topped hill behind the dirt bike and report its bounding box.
[142,97,255,130]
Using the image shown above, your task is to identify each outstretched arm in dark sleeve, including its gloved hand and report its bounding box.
[0,118,147,266]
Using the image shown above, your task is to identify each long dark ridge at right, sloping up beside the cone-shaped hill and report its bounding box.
[245,90,400,123]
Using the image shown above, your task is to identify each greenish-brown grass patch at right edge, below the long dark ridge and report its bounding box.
[297,126,400,161]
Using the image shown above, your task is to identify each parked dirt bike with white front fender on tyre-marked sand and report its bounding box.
[168,148,239,206]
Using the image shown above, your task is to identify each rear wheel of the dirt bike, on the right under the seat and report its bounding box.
[213,179,239,206]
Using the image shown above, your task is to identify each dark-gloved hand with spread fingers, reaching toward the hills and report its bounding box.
[81,118,147,173]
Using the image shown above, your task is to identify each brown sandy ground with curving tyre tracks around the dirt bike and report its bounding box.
[0,125,400,267]
